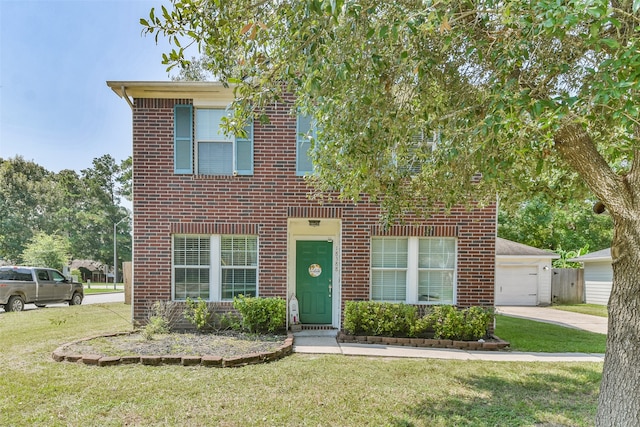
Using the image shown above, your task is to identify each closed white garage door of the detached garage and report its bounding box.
[496,265,538,305]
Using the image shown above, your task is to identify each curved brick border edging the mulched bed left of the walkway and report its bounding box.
[51,332,293,368]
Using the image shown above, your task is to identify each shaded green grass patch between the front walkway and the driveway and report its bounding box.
[495,315,607,353]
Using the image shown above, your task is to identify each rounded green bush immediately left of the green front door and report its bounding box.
[233,295,287,333]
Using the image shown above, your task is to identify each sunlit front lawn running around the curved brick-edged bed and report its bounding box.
[0,303,602,427]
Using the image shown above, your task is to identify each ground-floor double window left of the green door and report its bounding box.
[173,235,258,301]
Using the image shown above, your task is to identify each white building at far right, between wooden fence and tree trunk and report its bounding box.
[569,248,613,305]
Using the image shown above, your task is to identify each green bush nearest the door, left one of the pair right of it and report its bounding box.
[344,301,418,337]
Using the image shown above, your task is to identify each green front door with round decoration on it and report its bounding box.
[296,240,333,325]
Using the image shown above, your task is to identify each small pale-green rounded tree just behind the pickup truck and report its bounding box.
[22,232,71,270]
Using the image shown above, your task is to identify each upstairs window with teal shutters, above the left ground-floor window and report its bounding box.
[174,105,253,175]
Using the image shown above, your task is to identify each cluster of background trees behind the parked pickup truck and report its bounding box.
[0,155,131,267]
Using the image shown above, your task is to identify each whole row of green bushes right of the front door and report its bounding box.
[343,301,494,341]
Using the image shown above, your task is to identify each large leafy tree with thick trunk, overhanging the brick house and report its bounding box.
[141,0,640,426]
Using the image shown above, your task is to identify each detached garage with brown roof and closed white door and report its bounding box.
[495,237,560,306]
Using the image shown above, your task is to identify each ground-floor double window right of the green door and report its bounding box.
[371,237,456,304]
